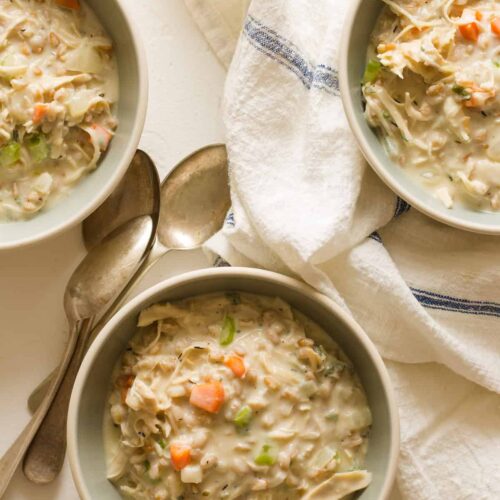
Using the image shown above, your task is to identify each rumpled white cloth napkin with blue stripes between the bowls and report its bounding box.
[185,0,500,500]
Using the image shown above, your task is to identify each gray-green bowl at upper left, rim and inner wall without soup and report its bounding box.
[0,0,148,250]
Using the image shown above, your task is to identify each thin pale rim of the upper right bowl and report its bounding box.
[339,0,500,235]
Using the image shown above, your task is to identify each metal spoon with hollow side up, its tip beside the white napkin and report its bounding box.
[24,145,231,483]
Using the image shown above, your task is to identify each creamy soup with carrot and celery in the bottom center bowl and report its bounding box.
[104,293,372,500]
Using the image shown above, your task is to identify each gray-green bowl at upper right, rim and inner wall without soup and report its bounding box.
[339,0,500,234]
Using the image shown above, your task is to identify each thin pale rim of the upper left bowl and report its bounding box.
[0,0,149,251]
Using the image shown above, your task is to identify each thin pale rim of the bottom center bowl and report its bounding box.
[67,267,400,500]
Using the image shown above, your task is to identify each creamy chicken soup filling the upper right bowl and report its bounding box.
[363,0,500,210]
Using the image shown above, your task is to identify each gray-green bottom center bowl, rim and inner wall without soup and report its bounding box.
[68,268,399,500]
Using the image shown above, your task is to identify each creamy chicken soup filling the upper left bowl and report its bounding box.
[0,0,118,222]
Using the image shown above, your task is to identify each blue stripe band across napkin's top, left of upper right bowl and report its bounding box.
[244,16,340,96]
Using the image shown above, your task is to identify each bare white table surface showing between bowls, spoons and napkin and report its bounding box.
[0,0,402,500]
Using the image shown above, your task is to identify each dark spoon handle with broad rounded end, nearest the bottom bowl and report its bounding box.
[23,321,92,484]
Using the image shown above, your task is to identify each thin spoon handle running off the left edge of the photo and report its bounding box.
[0,323,82,498]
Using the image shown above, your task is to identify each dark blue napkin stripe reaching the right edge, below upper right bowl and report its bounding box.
[411,288,500,318]
